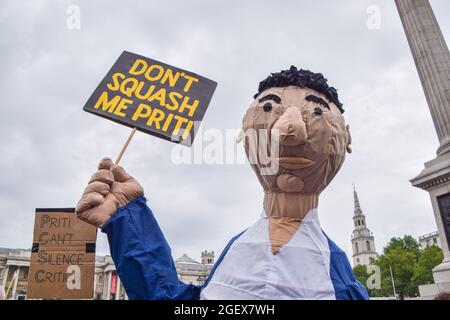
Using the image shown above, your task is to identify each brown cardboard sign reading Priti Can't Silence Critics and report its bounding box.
[27,208,97,299]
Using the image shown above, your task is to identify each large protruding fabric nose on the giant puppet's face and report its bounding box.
[273,107,308,147]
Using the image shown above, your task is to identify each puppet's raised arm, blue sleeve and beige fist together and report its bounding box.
[76,158,200,300]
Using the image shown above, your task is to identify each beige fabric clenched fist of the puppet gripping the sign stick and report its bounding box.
[75,158,144,228]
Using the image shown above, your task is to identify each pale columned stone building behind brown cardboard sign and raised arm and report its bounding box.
[0,248,214,300]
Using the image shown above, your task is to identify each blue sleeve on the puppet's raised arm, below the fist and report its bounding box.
[102,196,200,300]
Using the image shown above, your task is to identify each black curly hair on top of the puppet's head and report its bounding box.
[254,66,344,113]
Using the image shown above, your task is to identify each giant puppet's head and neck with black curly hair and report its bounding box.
[241,67,351,252]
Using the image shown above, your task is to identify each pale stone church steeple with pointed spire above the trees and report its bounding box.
[352,187,377,266]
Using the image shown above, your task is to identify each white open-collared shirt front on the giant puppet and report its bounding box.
[200,209,335,300]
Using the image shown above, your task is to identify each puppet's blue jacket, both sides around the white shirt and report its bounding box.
[102,197,368,300]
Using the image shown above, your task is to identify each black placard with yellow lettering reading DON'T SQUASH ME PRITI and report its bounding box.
[83,51,217,146]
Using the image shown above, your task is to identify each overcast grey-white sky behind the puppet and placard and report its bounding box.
[0,0,450,259]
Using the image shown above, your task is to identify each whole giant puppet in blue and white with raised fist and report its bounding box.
[76,67,368,300]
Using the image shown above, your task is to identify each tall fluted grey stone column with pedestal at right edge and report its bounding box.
[395,0,450,297]
